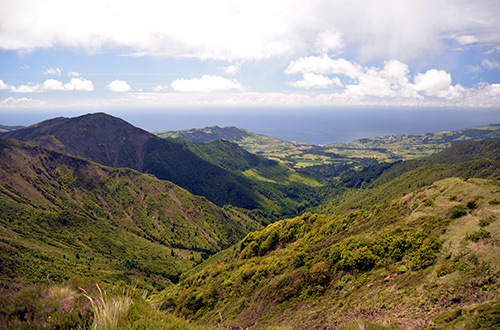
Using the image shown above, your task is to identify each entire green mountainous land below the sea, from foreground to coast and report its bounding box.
[0,113,500,329]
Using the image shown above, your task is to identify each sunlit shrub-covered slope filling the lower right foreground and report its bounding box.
[157,178,500,329]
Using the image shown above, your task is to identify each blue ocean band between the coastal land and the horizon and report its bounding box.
[0,108,500,144]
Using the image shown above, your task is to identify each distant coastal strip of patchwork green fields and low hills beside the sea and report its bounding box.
[155,124,500,168]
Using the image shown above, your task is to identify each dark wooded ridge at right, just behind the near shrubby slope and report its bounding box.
[316,140,500,213]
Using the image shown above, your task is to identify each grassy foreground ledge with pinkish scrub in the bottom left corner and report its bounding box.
[0,279,210,330]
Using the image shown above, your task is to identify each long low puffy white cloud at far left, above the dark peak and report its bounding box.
[8,78,94,93]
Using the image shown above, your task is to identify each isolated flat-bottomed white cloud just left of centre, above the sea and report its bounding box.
[171,75,243,92]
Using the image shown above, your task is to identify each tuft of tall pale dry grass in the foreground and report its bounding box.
[81,284,132,330]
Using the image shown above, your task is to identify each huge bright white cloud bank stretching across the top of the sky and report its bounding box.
[0,0,500,61]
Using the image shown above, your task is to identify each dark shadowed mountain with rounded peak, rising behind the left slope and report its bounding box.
[0,113,281,211]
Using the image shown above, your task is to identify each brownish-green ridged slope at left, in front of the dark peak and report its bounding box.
[0,140,260,288]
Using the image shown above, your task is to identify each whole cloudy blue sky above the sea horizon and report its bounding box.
[0,0,500,122]
